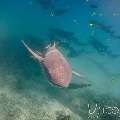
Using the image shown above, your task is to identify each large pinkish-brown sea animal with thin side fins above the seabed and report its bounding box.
[22,40,87,88]
